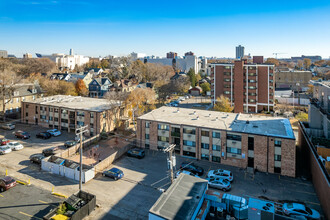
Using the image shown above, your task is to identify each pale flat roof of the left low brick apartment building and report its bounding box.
[24,95,120,112]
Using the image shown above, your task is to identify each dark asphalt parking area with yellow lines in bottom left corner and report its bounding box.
[0,179,63,220]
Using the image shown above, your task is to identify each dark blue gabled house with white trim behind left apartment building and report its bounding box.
[88,77,113,98]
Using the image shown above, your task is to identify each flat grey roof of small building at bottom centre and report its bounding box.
[149,174,207,220]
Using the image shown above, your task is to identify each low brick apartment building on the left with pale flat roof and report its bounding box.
[21,95,124,136]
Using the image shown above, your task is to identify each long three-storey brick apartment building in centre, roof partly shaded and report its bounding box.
[137,107,296,177]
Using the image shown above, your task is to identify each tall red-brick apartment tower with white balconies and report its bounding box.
[211,59,275,113]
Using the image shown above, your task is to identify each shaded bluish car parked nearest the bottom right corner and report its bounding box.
[282,203,321,219]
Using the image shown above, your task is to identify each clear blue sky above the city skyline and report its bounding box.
[0,0,330,59]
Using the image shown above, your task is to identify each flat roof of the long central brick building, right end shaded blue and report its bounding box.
[139,106,295,139]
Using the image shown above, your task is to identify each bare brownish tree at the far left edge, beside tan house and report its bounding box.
[0,59,23,121]
